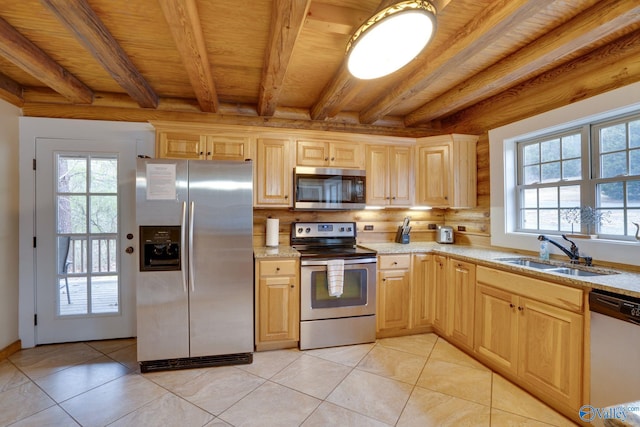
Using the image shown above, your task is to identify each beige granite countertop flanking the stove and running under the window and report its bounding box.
[253,242,640,298]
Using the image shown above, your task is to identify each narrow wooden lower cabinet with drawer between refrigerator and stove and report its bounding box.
[255,259,300,351]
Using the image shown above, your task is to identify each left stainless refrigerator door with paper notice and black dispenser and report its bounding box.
[136,159,189,361]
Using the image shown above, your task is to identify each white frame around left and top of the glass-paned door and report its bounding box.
[19,117,155,348]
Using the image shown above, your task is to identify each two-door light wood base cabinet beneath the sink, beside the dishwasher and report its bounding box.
[474,267,584,417]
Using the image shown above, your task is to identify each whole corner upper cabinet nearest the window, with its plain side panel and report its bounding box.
[416,134,478,208]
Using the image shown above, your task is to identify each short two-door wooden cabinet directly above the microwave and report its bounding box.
[296,139,364,169]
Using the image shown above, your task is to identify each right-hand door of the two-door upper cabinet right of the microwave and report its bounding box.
[390,147,414,206]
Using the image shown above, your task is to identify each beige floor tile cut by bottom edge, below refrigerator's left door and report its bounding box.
[109,393,215,427]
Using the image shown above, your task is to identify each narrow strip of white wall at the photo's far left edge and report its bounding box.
[0,100,20,350]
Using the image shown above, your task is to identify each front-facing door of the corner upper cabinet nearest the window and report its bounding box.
[417,145,451,207]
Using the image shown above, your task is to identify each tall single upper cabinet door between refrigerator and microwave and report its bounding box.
[253,138,293,207]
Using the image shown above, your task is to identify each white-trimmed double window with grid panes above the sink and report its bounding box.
[516,114,640,240]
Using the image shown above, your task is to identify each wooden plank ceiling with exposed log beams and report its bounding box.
[0,0,640,136]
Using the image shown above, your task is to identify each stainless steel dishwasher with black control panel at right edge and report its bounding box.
[592,290,640,425]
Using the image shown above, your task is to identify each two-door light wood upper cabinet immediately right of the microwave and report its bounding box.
[365,145,414,206]
